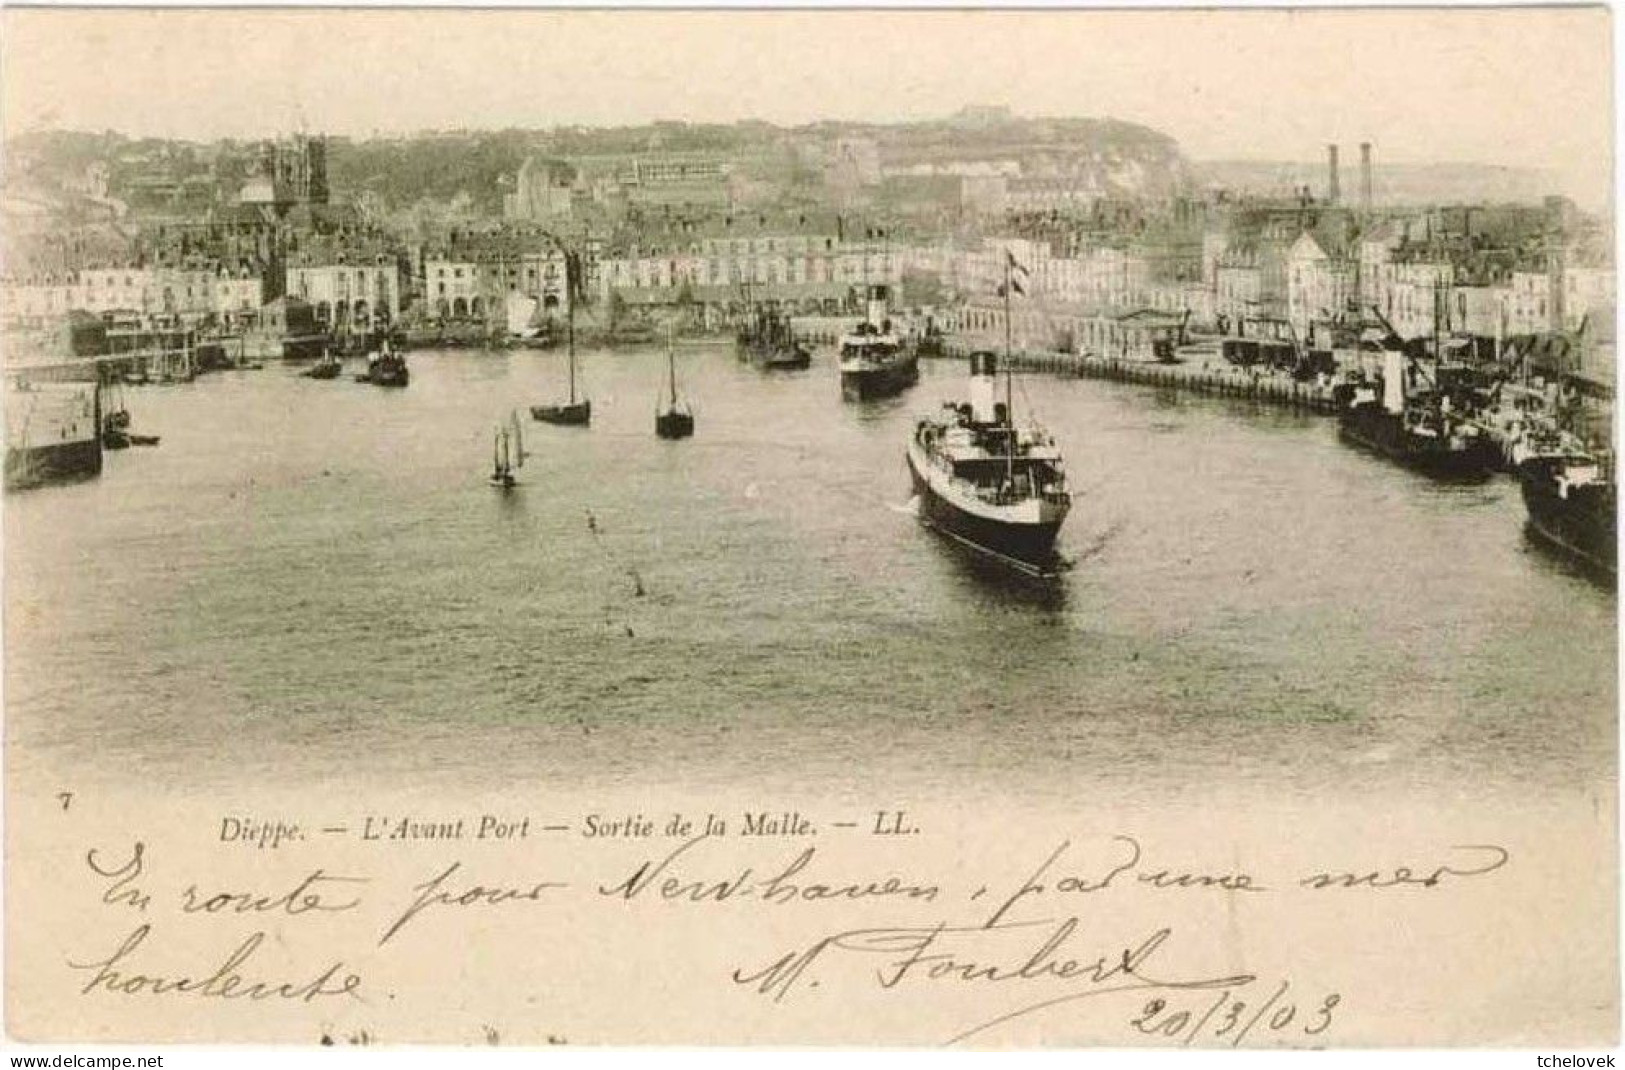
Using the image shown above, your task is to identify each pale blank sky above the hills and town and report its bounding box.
[0,8,1614,200]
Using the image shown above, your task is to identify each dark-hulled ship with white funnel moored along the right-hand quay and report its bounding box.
[1336,348,1495,480]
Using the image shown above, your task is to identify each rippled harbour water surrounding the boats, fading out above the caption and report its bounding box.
[5,345,1617,797]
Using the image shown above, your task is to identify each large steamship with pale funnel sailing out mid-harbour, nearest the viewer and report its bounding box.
[907,353,1073,576]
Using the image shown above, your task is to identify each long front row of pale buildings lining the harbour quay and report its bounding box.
[5,208,1614,354]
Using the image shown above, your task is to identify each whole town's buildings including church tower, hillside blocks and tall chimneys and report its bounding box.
[3,138,1614,378]
